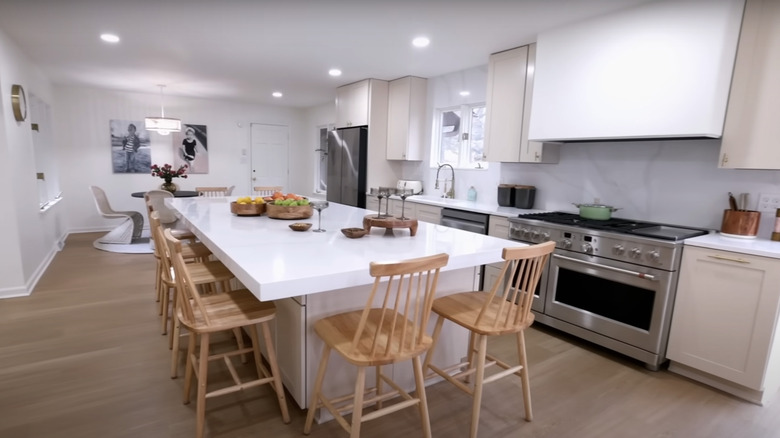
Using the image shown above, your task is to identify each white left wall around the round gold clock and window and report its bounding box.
[0,27,64,297]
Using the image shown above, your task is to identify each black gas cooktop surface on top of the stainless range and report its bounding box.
[518,211,709,241]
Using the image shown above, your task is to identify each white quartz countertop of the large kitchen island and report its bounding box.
[166,197,525,301]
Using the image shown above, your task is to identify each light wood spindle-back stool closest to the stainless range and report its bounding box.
[424,242,555,438]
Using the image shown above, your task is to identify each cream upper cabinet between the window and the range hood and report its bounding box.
[483,44,558,163]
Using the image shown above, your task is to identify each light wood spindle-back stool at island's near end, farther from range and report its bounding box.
[303,254,449,438]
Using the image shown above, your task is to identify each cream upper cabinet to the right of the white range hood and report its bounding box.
[720,0,780,169]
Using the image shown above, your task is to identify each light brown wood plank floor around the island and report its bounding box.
[0,233,780,438]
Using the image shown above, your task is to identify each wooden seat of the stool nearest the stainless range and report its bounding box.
[433,291,534,335]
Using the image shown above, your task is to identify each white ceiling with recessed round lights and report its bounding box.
[0,0,649,107]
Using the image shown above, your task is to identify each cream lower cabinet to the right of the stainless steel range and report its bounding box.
[667,245,780,404]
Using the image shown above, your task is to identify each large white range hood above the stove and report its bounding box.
[529,0,744,141]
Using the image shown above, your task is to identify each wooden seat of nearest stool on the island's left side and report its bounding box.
[179,289,276,333]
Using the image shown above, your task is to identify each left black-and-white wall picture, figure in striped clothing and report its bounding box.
[109,120,152,173]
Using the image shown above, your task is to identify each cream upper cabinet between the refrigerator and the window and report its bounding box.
[387,76,428,161]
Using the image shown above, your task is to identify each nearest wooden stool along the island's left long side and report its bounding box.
[164,230,290,438]
